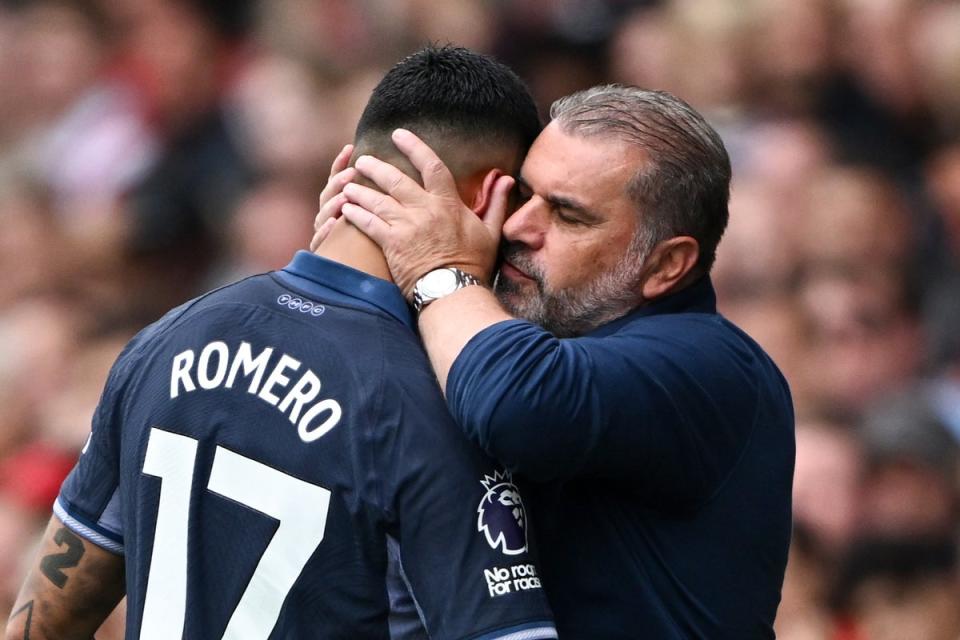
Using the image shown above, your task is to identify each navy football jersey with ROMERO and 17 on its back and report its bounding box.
[55,252,556,640]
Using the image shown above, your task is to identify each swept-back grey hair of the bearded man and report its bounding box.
[550,84,731,272]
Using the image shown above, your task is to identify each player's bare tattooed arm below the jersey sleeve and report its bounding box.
[5,516,124,640]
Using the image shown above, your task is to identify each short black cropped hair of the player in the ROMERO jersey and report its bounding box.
[355,46,540,149]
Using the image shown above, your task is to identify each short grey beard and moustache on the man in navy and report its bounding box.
[494,244,647,338]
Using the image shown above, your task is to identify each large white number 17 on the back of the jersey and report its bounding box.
[140,428,330,640]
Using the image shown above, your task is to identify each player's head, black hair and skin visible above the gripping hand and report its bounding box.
[353,46,541,204]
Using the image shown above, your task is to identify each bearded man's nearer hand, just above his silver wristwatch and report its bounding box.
[341,129,514,300]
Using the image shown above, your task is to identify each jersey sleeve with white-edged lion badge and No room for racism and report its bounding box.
[377,348,557,640]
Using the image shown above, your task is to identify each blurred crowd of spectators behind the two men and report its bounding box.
[0,0,960,640]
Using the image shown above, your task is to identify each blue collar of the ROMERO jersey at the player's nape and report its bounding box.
[276,251,416,332]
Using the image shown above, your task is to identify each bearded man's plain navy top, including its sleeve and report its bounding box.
[447,278,794,640]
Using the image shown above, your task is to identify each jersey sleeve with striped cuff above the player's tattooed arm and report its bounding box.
[53,340,138,554]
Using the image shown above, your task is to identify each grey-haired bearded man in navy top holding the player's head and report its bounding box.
[330,86,794,639]
